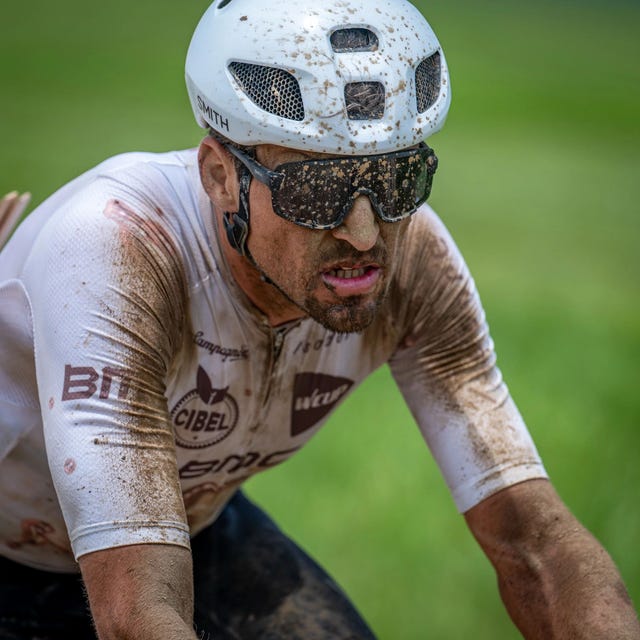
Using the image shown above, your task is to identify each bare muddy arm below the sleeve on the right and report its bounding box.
[465,480,640,640]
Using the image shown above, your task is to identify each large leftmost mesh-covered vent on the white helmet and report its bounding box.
[229,62,304,120]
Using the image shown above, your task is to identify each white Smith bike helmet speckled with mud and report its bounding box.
[186,0,451,155]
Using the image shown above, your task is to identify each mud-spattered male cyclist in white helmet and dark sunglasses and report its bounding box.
[0,0,640,639]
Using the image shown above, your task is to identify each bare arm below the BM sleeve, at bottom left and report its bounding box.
[80,544,196,640]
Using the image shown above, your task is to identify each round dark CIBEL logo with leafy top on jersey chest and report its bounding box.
[171,366,238,449]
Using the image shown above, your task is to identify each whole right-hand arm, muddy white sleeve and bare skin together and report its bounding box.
[391,209,640,640]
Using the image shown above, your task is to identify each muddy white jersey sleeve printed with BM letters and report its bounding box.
[24,185,189,558]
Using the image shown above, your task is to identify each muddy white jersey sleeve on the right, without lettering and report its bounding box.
[390,209,546,512]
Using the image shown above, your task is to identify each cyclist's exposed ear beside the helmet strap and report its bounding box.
[198,136,239,211]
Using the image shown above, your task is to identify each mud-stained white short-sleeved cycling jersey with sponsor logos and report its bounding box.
[0,150,545,571]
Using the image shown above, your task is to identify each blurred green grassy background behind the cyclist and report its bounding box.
[0,0,640,640]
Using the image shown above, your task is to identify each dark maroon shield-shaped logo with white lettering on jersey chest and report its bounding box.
[291,373,353,436]
